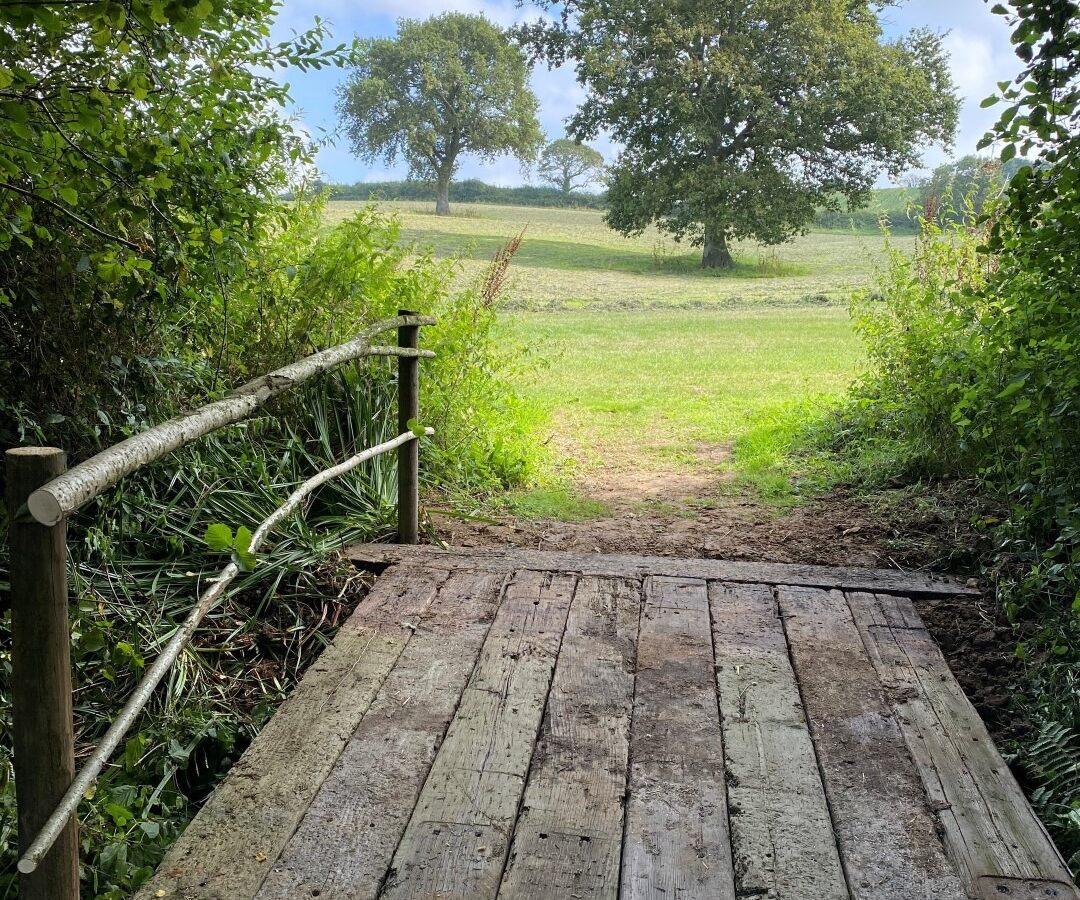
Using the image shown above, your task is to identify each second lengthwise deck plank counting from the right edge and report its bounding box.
[779,587,968,900]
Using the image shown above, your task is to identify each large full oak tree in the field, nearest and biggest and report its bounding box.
[517,0,959,268]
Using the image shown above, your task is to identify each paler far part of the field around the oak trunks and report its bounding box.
[327,201,914,310]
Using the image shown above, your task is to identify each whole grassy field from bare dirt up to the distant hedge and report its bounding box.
[328,202,894,512]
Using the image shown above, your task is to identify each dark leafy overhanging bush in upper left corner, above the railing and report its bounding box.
[0,0,341,459]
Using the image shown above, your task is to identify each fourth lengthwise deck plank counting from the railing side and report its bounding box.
[499,578,642,900]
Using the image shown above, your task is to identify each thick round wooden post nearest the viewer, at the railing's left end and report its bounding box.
[5,447,79,900]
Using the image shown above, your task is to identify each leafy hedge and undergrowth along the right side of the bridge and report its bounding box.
[829,0,1080,863]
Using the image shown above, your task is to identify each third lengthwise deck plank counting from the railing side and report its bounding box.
[380,572,577,900]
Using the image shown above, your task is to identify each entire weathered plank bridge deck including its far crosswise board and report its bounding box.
[138,547,1080,900]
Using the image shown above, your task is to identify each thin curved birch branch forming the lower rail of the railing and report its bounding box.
[18,428,435,874]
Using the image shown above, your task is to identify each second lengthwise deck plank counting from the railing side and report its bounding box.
[257,572,505,900]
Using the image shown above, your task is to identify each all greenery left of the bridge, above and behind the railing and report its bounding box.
[0,0,540,900]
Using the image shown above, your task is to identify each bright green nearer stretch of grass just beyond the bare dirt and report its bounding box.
[508,307,860,501]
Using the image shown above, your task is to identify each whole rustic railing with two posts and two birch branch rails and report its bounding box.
[4,309,435,900]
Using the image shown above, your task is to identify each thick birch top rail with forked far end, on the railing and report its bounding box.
[26,315,435,525]
